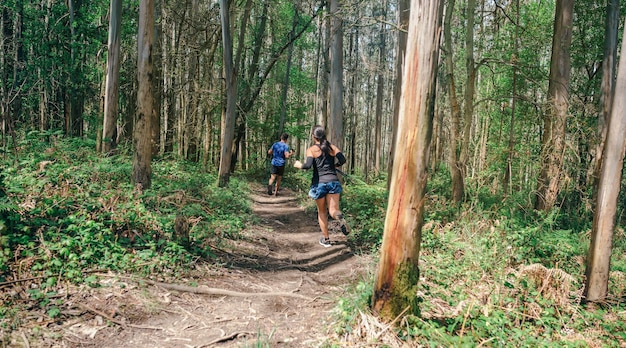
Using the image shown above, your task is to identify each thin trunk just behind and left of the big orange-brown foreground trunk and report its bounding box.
[387,0,410,189]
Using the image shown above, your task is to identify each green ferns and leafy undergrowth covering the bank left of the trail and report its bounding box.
[0,132,251,329]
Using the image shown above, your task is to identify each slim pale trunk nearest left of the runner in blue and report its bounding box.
[218,0,237,187]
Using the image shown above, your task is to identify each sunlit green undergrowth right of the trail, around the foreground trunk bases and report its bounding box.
[327,180,626,347]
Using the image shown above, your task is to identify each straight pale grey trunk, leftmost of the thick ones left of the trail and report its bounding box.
[100,0,122,153]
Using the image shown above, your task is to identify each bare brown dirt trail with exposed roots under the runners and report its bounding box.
[2,186,371,348]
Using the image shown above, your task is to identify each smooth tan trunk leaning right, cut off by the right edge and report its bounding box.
[583,21,626,302]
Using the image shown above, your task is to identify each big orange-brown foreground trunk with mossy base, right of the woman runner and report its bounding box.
[372,0,442,319]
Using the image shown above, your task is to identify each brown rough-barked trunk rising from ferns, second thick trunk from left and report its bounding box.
[132,0,154,189]
